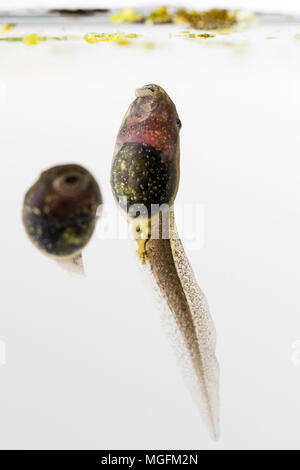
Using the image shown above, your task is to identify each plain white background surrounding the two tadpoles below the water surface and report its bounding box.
[0,2,300,449]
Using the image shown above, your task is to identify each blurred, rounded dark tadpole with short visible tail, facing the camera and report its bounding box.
[23,165,102,276]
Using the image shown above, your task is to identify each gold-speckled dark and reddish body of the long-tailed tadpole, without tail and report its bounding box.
[111,84,181,223]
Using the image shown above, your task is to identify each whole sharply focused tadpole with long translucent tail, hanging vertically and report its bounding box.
[111,85,219,438]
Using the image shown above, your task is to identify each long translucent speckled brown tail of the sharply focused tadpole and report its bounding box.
[147,212,219,439]
